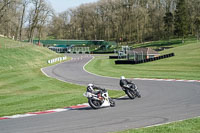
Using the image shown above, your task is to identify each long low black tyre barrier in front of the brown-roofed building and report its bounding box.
[115,53,175,64]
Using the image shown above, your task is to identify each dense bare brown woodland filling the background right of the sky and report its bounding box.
[46,0,200,43]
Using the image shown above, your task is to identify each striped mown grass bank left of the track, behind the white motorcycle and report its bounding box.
[0,38,123,116]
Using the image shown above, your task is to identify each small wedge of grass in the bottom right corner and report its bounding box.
[117,118,200,133]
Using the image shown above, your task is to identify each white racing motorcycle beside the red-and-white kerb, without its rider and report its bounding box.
[83,90,115,109]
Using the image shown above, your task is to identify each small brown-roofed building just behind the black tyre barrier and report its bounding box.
[127,48,160,61]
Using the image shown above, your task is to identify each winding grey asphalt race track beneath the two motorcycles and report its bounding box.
[0,55,200,133]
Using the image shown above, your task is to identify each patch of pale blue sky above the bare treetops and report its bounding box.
[48,0,98,13]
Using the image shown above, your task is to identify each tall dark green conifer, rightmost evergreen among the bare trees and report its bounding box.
[175,0,188,43]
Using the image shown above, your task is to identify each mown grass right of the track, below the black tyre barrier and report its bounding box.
[86,43,200,80]
